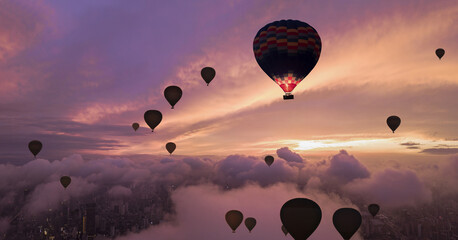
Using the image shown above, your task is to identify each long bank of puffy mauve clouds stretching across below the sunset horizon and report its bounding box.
[0,150,444,220]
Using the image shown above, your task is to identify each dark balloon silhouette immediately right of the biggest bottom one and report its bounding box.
[332,208,362,240]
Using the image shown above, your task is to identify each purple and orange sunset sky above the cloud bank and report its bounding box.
[0,0,458,163]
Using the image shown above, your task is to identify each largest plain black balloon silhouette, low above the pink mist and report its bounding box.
[280,198,321,240]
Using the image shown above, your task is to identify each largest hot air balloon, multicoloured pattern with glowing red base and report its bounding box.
[253,19,321,100]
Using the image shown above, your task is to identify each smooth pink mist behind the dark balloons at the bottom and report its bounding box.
[114,184,362,240]
